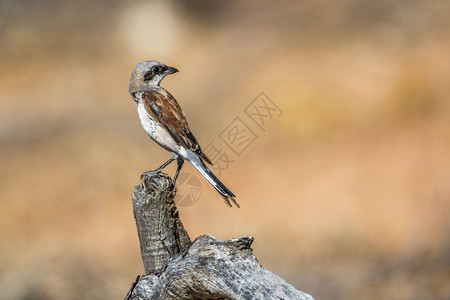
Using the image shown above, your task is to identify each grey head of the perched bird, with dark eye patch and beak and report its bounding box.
[128,60,178,94]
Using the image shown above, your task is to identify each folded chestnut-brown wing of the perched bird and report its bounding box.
[142,89,211,164]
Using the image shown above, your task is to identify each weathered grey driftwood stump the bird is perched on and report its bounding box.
[125,173,314,300]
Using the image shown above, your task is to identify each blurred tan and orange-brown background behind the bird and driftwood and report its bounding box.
[0,0,450,300]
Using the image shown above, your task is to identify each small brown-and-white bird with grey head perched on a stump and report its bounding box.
[128,60,240,207]
